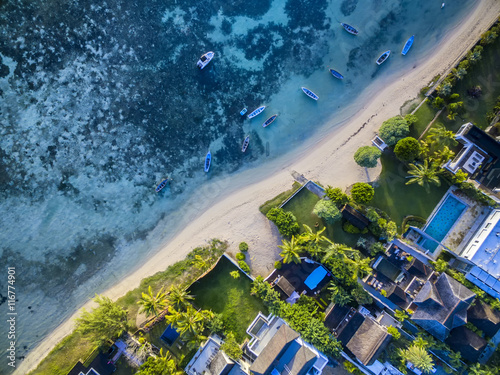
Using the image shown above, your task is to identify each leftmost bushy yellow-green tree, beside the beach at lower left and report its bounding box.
[76,294,127,345]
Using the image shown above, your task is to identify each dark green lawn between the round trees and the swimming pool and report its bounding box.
[370,152,448,226]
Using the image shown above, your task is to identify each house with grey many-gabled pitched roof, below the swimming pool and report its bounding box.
[410,273,476,341]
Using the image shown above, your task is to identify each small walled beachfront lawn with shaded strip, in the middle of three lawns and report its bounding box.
[283,188,359,246]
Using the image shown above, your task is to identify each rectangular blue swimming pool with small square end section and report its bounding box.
[417,194,467,253]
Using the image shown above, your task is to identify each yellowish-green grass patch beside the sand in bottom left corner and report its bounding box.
[30,332,95,375]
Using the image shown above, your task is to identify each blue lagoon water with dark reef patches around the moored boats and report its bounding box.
[0,0,475,373]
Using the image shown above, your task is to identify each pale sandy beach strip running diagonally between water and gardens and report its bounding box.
[15,0,500,374]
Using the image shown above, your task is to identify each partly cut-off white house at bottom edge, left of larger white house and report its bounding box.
[184,335,248,375]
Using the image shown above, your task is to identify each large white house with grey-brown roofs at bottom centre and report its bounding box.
[245,312,328,375]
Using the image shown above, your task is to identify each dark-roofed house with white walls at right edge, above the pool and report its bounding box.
[443,122,500,191]
